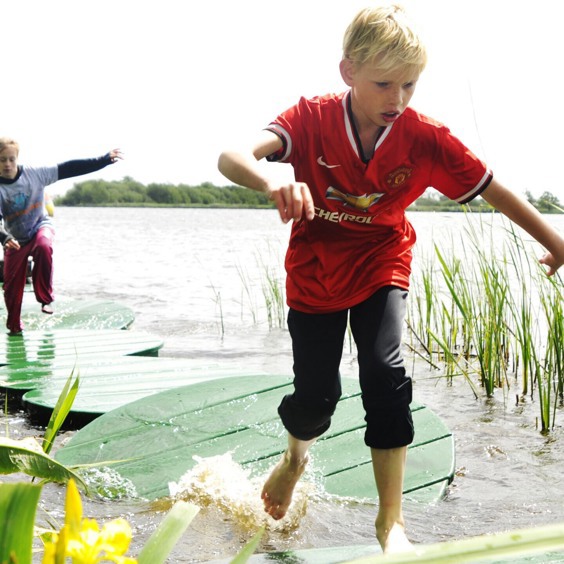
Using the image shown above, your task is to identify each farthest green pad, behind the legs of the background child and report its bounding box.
[0,292,135,331]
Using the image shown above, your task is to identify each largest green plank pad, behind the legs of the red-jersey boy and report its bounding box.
[55,375,454,502]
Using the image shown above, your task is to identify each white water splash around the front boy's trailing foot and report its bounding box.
[169,453,314,532]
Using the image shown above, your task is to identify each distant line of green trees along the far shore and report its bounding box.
[54,176,564,213]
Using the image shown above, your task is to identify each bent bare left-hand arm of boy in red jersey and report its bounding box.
[217,131,315,223]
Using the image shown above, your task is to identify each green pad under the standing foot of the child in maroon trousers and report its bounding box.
[0,329,163,368]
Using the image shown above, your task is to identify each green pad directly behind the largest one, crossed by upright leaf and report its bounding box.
[20,356,249,427]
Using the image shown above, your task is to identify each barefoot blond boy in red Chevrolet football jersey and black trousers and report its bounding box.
[218,6,564,553]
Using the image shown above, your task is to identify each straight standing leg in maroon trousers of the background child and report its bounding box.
[4,245,29,333]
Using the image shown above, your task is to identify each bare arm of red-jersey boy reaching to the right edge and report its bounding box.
[481,179,564,276]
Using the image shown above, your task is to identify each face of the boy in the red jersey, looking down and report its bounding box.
[341,59,419,129]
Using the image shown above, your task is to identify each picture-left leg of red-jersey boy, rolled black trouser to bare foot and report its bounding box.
[261,310,348,519]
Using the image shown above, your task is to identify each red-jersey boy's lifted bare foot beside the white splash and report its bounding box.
[260,451,307,520]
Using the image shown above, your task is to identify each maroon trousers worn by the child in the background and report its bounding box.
[4,227,55,333]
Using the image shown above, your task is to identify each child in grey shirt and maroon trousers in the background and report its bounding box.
[0,137,122,335]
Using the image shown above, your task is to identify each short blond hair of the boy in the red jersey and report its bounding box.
[343,4,427,73]
